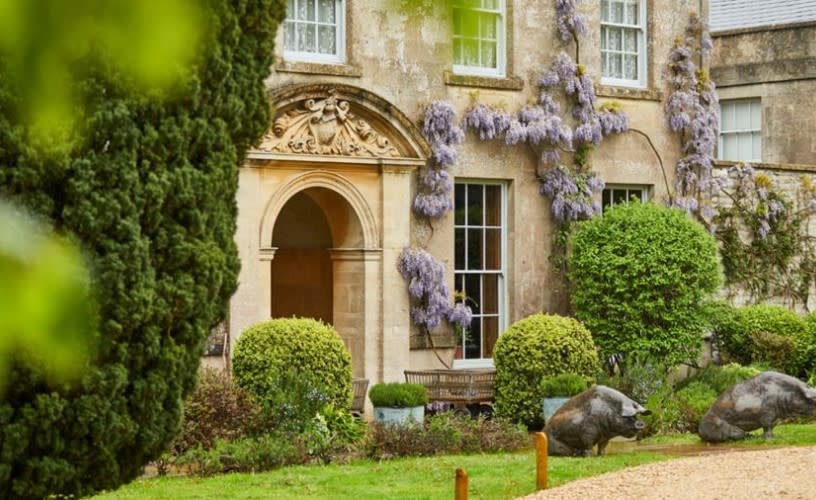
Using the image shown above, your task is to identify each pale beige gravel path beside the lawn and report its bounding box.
[525,447,816,500]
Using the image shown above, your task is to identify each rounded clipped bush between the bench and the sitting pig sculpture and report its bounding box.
[493,314,598,428]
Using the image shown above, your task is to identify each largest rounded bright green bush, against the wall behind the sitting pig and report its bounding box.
[569,202,720,365]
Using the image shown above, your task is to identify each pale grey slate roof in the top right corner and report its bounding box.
[709,0,816,32]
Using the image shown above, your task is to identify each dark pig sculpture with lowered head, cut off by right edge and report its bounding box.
[697,371,816,443]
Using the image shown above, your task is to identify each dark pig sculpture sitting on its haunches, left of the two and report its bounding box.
[544,385,651,456]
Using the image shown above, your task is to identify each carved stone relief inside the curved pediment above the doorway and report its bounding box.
[258,90,400,157]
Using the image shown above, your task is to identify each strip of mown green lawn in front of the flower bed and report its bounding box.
[95,424,816,500]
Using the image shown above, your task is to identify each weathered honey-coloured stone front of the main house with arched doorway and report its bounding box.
[212,0,706,381]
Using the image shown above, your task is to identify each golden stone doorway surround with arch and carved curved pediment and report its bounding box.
[229,83,430,382]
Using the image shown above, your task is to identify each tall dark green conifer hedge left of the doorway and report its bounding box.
[0,0,285,498]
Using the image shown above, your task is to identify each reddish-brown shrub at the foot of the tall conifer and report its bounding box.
[173,368,262,453]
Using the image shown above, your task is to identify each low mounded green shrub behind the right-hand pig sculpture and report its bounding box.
[716,304,809,376]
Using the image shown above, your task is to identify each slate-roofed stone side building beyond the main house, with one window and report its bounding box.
[711,0,816,310]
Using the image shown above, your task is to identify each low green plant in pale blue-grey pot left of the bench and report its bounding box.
[368,382,428,424]
